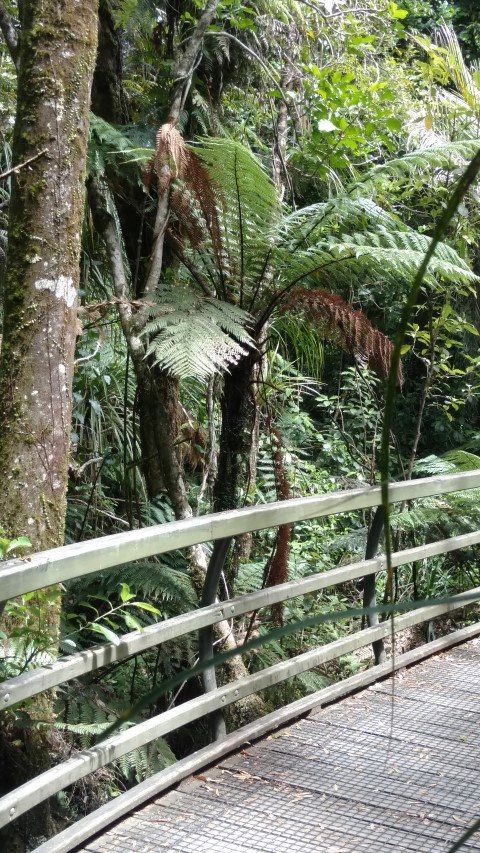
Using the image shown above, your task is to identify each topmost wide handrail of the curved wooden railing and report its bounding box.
[0,471,480,601]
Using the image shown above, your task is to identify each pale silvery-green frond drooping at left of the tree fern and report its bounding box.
[143,286,254,379]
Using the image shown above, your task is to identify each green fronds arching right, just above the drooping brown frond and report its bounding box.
[272,197,477,312]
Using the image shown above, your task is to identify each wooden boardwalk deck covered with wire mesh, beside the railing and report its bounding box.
[82,640,480,853]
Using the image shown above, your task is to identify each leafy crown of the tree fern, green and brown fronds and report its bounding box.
[119,132,476,378]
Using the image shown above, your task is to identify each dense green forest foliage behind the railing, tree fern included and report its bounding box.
[0,0,480,844]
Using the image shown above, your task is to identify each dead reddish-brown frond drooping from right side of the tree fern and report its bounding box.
[286,288,402,384]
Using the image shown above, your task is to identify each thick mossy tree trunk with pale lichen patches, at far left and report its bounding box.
[0,5,98,850]
